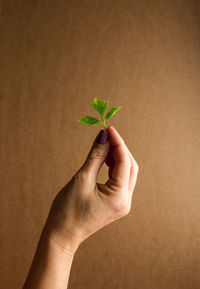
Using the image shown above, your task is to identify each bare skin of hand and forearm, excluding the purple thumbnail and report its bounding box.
[23,126,139,289]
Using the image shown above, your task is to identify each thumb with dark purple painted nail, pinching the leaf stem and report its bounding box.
[82,130,110,182]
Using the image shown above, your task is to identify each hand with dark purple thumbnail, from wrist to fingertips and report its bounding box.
[45,126,138,251]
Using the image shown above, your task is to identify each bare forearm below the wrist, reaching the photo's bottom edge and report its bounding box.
[23,223,75,289]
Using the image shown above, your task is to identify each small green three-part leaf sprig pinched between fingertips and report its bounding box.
[78,97,121,129]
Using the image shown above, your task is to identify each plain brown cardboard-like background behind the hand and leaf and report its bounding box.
[0,0,200,289]
